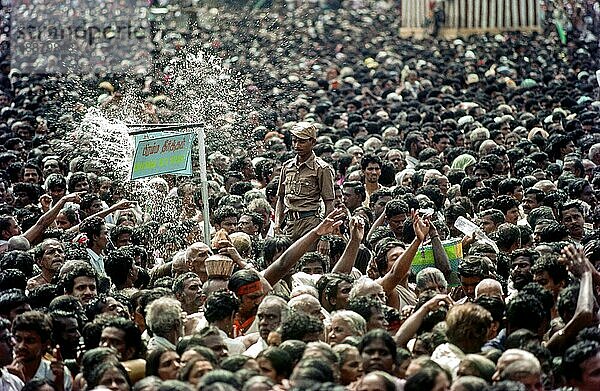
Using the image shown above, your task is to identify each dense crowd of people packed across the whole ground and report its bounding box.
[0,1,600,391]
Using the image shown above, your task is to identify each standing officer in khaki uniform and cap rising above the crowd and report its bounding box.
[275,122,335,240]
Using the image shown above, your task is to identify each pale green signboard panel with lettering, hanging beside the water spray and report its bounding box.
[131,132,194,179]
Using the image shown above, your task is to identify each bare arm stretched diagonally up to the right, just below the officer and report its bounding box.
[263,208,345,285]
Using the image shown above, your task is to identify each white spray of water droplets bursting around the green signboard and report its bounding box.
[67,49,251,222]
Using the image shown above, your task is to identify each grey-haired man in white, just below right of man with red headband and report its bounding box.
[243,296,289,358]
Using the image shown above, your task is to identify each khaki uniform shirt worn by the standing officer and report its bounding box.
[277,153,335,212]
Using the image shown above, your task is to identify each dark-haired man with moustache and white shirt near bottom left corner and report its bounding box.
[12,311,73,391]
